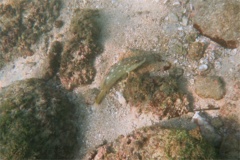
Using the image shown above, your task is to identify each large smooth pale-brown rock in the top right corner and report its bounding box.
[193,0,240,48]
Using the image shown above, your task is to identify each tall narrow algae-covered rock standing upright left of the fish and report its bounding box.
[60,9,101,90]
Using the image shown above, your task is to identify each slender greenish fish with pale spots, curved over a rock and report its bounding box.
[95,56,146,104]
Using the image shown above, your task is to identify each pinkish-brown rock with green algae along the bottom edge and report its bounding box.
[85,126,216,160]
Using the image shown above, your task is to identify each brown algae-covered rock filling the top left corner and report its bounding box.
[0,0,61,68]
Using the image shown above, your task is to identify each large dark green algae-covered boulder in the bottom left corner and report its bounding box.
[0,79,77,160]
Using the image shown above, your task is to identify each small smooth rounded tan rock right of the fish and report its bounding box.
[195,76,226,100]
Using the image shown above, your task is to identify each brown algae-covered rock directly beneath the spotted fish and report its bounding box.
[123,73,189,119]
